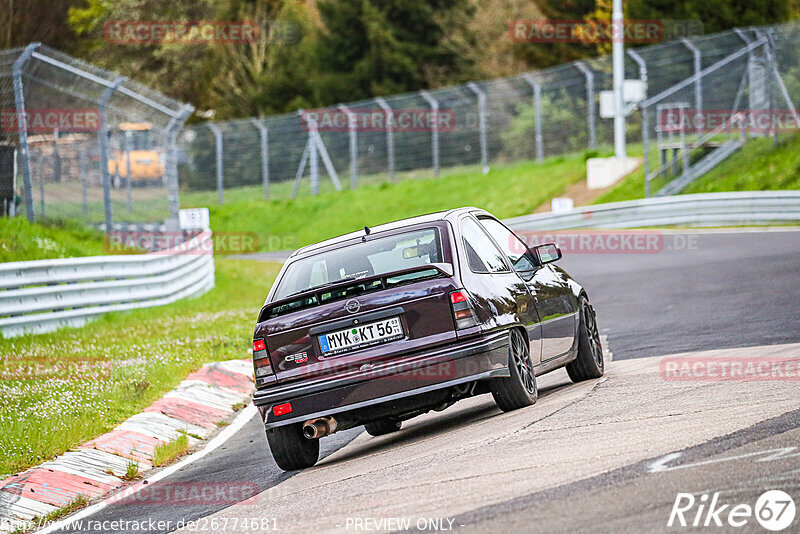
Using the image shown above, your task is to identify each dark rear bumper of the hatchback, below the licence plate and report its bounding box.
[253,332,509,428]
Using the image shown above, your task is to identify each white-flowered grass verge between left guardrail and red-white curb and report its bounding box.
[0,259,279,476]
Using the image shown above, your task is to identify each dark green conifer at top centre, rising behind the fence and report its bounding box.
[316,0,471,103]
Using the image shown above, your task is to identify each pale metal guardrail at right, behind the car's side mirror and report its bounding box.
[505,191,800,230]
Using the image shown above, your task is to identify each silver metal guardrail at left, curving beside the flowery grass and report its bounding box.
[0,230,214,337]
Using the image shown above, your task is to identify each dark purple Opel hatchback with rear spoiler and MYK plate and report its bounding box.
[253,208,603,470]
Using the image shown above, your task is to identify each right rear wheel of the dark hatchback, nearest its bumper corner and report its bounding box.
[489,330,539,412]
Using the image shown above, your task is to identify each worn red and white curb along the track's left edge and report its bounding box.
[0,359,253,533]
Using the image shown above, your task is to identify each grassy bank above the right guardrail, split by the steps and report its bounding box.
[594,135,800,204]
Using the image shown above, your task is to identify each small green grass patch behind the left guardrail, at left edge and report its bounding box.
[0,217,106,263]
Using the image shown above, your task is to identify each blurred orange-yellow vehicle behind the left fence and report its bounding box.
[108,122,164,186]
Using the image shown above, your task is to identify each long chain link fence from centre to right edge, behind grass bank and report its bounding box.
[179,23,800,203]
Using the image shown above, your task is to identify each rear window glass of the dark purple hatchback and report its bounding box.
[273,228,443,300]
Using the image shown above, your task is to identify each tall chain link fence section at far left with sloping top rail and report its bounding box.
[0,44,193,230]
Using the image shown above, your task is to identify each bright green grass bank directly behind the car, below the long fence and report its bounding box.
[181,149,612,251]
